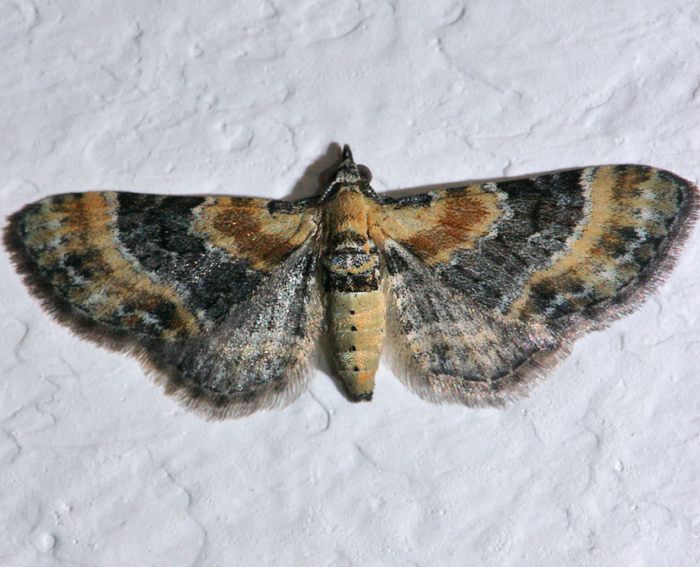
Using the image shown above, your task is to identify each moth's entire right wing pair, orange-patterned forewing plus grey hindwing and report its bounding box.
[375,165,697,404]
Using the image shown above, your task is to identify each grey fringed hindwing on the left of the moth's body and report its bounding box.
[160,235,323,418]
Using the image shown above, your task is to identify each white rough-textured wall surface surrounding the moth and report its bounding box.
[0,0,700,567]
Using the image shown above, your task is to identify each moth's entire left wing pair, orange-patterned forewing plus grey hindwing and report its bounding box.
[5,192,321,418]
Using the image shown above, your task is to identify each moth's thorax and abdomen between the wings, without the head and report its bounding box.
[323,184,386,401]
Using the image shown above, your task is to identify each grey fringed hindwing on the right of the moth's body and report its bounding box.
[383,240,558,405]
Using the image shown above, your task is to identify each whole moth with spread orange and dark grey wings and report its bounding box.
[5,146,698,419]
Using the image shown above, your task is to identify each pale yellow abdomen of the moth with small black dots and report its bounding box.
[328,289,386,401]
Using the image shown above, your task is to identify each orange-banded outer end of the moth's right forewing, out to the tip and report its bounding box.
[501,166,698,336]
